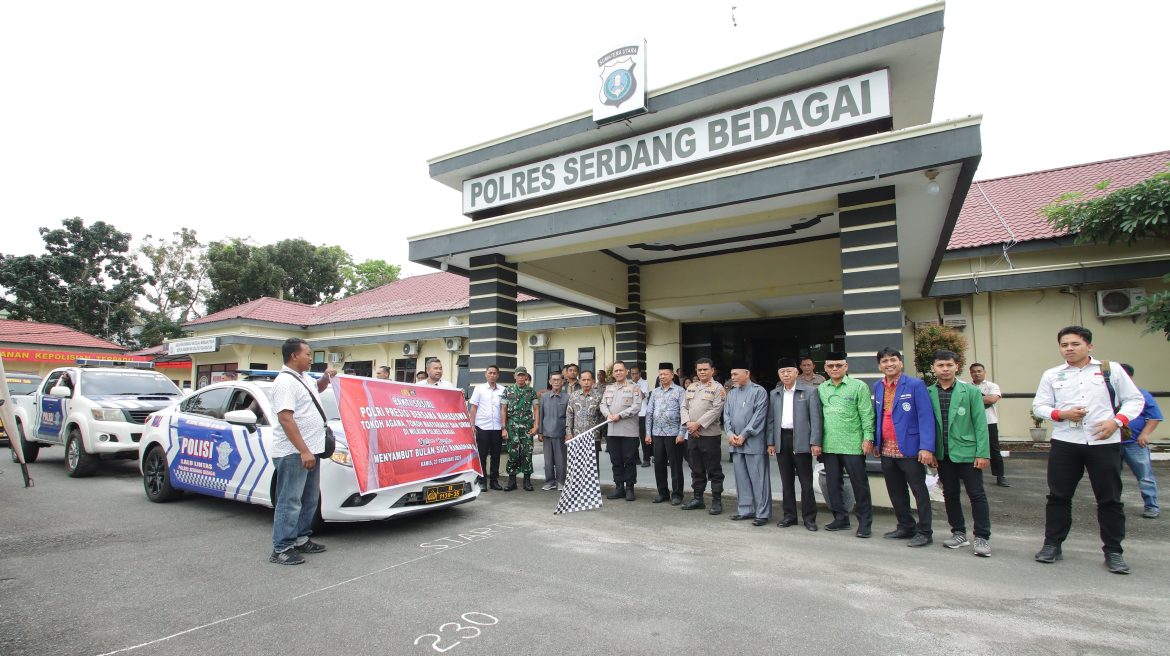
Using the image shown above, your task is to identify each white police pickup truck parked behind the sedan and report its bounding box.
[13,360,183,477]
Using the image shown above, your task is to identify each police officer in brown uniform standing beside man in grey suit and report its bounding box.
[680,358,727,515]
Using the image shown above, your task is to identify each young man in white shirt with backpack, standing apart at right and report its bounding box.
[1032,326,1145,574]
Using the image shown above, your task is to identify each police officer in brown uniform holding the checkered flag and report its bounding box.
[600,360,642,502]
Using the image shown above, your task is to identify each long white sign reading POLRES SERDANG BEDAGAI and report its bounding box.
[463,69,890,214]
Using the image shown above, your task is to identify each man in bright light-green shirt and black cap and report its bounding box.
[812,352,874,538]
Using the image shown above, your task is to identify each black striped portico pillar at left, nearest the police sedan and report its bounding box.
[468,255,516,384]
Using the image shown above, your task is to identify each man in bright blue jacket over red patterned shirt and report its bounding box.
[874,346,935,547]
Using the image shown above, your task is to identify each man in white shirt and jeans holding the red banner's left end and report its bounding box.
[268,338,337,565]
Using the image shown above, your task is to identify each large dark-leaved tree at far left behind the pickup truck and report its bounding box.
[0,217,146,344]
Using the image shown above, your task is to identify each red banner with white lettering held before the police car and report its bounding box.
[333,375,483,493]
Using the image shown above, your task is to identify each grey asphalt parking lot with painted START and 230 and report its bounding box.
[0,450,1170,656]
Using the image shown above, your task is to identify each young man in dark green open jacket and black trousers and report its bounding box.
[928,351,991,558]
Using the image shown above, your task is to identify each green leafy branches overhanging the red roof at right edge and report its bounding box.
[1040,164,1170,340]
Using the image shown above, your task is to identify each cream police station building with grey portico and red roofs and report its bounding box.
[172,5,1170,439]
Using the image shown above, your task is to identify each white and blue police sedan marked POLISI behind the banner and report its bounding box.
[139,371,480,523]
